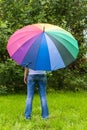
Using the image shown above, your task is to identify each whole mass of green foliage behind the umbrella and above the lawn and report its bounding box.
[0,0,87,91]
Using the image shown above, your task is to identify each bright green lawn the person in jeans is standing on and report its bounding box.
[0,92,87,130]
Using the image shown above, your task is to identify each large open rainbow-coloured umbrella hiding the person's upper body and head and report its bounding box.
[7,23,79,71]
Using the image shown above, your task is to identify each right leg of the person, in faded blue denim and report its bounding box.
[38,75,49,118]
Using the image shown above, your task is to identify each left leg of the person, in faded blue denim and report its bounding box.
[25,75,35,118]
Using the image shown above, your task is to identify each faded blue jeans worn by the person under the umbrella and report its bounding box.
[25,74,49,118]
